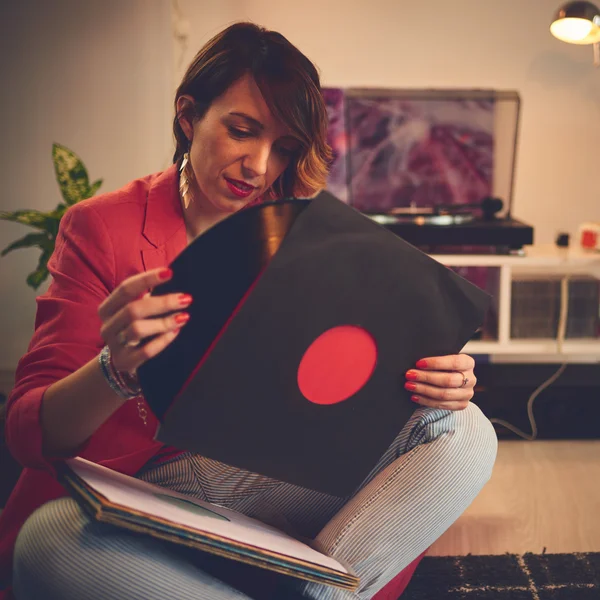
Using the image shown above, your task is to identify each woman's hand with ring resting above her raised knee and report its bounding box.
[404,354,477,410]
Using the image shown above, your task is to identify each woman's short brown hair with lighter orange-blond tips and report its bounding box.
[173,23,332,198]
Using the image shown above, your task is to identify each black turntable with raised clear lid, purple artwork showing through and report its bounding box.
[324,88,533,253]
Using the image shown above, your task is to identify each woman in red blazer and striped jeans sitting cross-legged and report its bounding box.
[0,24,496,600]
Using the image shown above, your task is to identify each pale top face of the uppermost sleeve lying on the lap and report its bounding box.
[66,458,349,574]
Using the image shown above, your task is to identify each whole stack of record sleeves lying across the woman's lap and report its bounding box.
[61,458,359,590]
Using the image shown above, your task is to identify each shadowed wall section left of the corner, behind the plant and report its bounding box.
[0,0,172,376]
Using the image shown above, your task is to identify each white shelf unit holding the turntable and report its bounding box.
[431,245,600,362]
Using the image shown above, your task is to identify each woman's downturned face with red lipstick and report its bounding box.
[178,75,299,216]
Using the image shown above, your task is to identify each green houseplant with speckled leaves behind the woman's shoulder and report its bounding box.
[0,144,102,290]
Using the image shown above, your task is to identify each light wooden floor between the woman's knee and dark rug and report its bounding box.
[429,440,600,556]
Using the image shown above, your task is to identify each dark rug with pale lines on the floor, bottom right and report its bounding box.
[401,552,600,600]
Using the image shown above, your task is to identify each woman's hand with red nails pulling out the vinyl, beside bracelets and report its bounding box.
[98,268,192,373]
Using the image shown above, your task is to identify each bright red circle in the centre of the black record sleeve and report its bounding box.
[298,325,377,404]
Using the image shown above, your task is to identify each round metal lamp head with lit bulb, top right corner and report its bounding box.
[550,2,600,44]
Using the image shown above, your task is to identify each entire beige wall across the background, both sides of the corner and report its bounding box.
[0,0,600,369]
